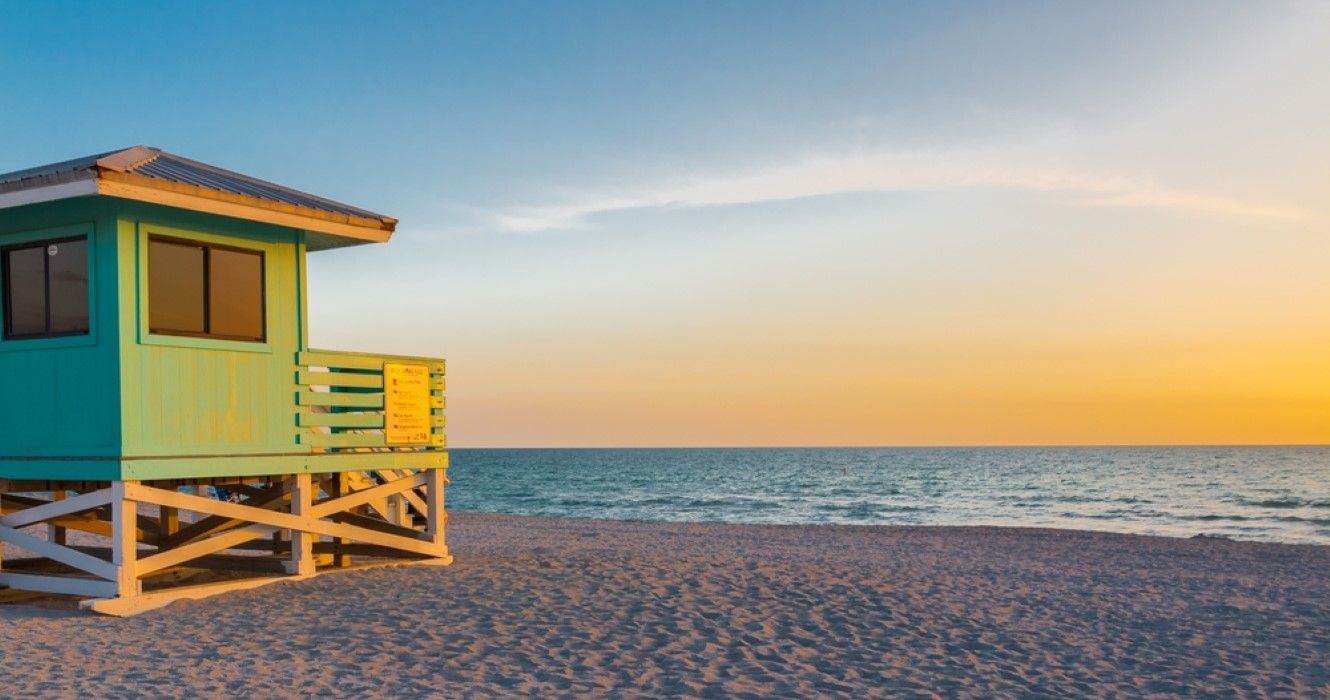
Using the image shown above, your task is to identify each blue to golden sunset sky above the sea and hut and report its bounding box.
[0,0,1330,447]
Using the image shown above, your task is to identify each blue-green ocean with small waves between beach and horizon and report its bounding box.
[448,446,1330,544]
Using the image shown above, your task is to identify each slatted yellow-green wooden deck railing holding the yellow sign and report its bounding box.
[295,350,447,452]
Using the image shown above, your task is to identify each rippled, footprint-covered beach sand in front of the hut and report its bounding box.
[0,514,1330,697]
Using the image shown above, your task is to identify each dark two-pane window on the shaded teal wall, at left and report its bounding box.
[0,237,88,341]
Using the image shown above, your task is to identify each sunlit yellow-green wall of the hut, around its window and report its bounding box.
[118,202,303,478]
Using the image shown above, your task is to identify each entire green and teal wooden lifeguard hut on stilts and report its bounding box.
[0,146,452,615]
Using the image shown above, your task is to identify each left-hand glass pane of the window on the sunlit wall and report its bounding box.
[148,240,207,333]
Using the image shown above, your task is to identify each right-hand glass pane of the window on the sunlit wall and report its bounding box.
[207,248,263,339]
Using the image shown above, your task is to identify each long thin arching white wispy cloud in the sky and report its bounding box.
[491,153,1302,232]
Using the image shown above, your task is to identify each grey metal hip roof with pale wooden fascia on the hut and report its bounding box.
[0,146,396,248]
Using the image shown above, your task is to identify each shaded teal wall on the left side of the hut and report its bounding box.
[0,197,121,479]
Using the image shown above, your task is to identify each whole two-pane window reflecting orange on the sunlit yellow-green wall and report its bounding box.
[148,237,265,342]
